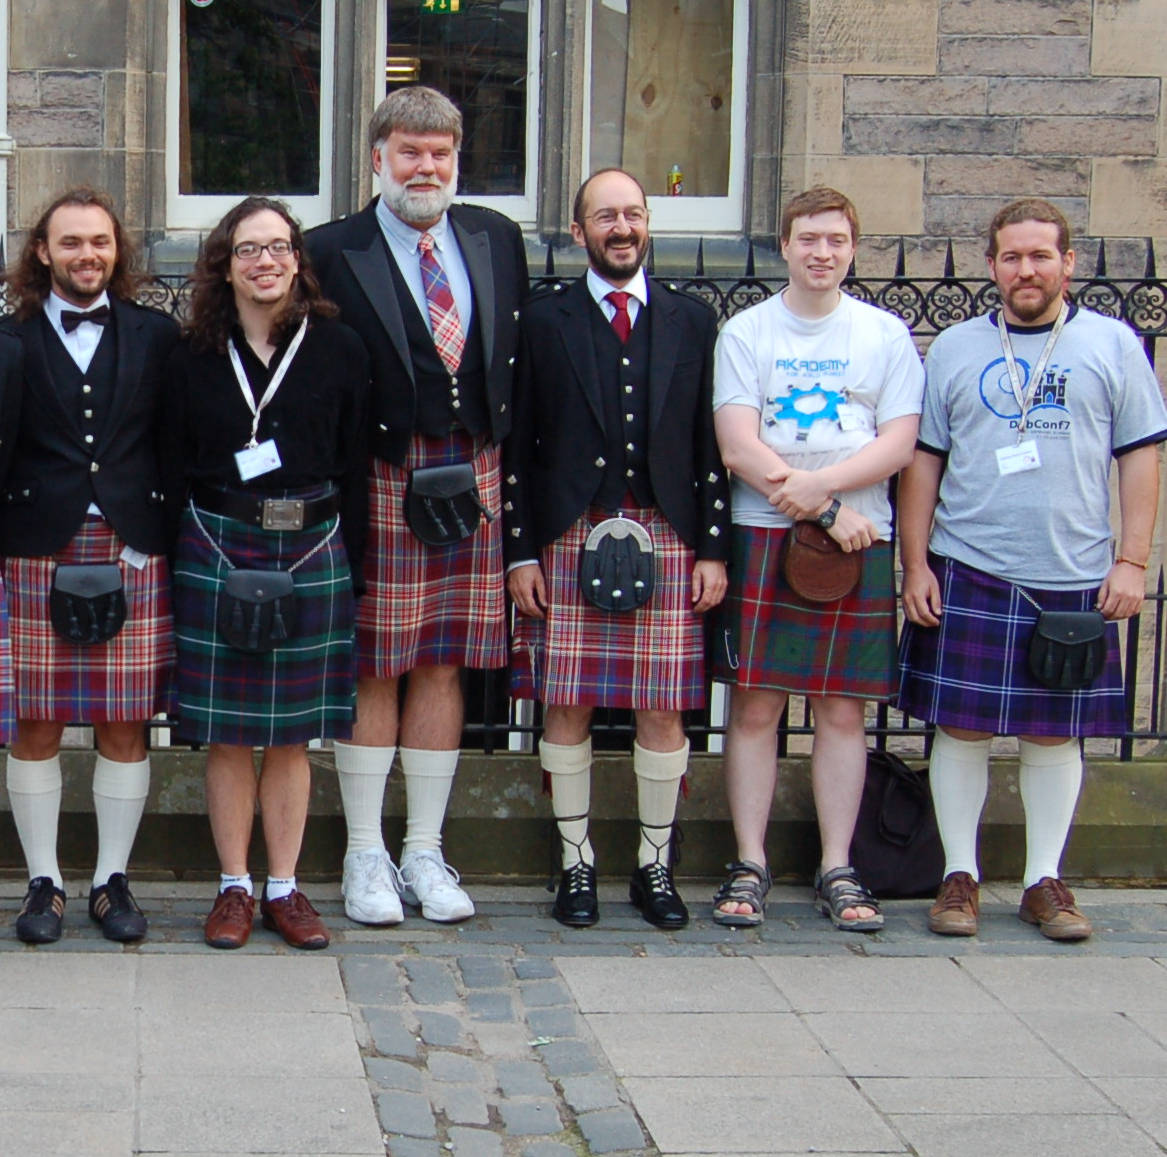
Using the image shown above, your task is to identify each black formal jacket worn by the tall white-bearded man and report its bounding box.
[305,198,529,466]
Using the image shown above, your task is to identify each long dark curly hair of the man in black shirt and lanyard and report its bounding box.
[183,197,340,354]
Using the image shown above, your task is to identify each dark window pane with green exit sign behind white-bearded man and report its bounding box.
[385,0,529,196]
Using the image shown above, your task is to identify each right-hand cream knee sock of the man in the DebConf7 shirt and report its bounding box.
[1019,739,1082,887]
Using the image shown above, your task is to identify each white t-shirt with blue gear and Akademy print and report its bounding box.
[713,294,924,539]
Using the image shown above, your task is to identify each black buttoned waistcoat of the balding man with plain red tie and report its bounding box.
[592,306,656,510]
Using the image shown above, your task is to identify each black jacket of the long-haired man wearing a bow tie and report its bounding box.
[0,294,179,557]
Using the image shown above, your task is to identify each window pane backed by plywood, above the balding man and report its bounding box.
[591,0,733,197]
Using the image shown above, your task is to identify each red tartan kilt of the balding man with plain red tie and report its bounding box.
[511,507,705,711]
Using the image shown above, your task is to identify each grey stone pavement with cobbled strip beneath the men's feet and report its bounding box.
[0,880,1167,1157]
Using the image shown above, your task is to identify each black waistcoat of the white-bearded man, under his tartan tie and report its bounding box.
[385,245,490,437]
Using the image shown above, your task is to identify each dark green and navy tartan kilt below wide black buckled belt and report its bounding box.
[174,506,356,747]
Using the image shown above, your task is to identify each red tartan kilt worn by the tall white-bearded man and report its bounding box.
[357,432,506,678]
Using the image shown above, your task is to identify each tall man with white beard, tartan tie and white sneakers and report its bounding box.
[306,86,527,925]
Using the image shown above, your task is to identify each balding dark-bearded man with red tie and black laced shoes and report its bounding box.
[503,169,729,929]
